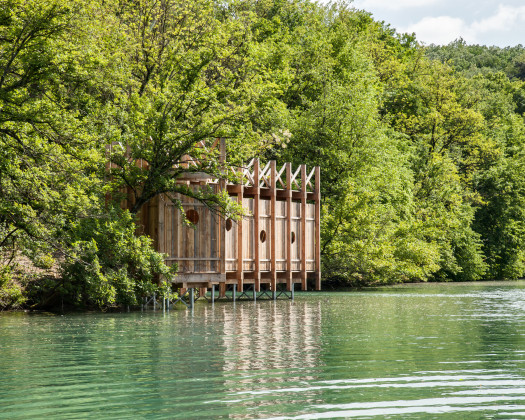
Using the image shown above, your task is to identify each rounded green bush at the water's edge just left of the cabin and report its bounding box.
[57,209,174,307]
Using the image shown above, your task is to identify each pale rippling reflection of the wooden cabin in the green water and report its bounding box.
[195,301,322,418]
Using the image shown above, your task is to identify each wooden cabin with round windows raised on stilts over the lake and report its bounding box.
[117,139,321,295]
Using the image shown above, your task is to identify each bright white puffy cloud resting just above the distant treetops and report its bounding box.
[399,16,475,44]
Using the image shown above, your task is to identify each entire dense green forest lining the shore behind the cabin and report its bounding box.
[0,0,525,308]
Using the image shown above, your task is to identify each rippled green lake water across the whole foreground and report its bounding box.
[0,282,525,419]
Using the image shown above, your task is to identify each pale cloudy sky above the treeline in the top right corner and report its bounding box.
[352,0,525,47]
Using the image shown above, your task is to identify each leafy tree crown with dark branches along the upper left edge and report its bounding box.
[0,0,97,270]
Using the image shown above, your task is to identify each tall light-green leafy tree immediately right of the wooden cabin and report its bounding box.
[249,1,439,284]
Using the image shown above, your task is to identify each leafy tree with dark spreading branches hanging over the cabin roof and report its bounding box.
[104,0,288,213]
